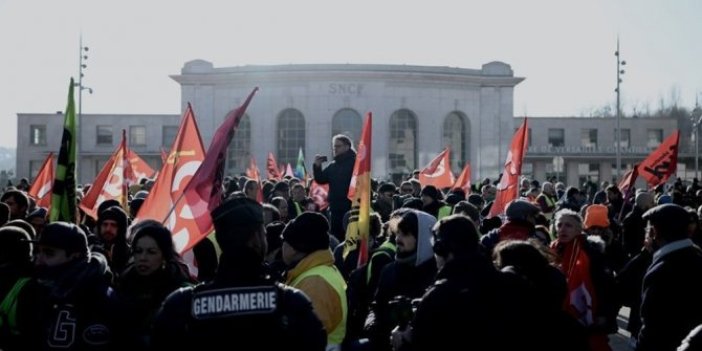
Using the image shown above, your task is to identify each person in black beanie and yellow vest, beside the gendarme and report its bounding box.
[282,212,348,350]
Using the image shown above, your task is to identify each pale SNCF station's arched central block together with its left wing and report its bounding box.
[17,60,523,182]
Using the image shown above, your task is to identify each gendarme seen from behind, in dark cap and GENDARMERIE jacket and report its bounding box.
[153,198,327,350]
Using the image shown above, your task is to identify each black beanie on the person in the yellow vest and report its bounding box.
[283,212,329,253]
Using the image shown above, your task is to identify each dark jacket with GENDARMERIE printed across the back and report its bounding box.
[152,251,327,351]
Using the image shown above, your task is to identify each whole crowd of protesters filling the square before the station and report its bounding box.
[0,149,702,351]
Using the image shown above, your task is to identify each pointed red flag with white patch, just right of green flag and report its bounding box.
[79,129,131,219]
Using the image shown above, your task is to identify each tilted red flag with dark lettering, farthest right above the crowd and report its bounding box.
[638,130,680,187]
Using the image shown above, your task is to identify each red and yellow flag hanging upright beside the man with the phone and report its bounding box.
[343,112,373,266]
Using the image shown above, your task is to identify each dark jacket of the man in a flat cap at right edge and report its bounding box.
[636,239,702,351]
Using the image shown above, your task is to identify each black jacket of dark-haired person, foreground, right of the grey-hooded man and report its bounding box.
[412,254,536,350]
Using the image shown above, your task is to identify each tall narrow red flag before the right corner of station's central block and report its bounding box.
[488,117,529,218]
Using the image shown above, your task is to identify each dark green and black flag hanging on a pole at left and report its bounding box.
[49,78,78,223]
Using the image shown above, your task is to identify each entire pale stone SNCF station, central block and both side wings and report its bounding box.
[16,60,694,190]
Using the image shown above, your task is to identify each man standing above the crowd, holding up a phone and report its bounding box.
[312,134,356,241]
